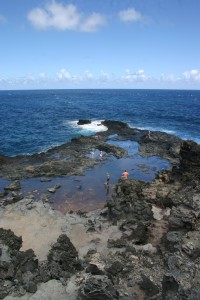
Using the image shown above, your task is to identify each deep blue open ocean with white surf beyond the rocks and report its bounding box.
[0,89,200,156]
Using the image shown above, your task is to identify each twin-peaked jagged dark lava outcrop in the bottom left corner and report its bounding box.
[0,228,82,299]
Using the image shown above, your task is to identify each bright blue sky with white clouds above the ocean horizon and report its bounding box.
[0,0,200,90]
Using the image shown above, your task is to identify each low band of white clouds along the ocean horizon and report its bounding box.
[0,68,200,89]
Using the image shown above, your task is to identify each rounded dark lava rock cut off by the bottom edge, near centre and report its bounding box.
[79,275,119,300]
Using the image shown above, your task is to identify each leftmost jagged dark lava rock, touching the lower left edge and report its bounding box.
[0,228,39,299]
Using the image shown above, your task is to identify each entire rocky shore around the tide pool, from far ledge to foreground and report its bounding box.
[0,120,200,300]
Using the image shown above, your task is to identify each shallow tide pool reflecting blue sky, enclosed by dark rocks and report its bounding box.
[0,141,170,212]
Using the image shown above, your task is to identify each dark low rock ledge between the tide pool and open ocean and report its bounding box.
[0,120,182,180]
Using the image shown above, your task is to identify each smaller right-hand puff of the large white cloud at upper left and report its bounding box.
[80,13,106,32]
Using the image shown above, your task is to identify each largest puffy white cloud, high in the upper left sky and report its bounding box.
[28,1,106,32]
